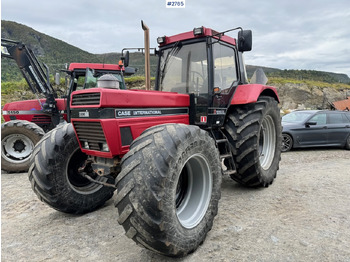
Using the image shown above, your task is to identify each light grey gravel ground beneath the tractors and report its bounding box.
[1,149,350,262]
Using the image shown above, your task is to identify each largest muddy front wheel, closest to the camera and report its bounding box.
[115,124,222,257]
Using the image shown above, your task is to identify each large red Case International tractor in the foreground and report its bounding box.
[29,23,282,257]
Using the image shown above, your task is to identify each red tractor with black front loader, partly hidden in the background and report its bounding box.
[1,39,134,172]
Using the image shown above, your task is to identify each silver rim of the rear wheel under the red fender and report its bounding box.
[259,115,276,170]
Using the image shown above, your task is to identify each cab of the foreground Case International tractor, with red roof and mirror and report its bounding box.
[155,27,252,126]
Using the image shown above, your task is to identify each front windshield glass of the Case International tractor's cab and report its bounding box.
[158,42,208,95]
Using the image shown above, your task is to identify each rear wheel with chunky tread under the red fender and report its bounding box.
[225,96,282,187]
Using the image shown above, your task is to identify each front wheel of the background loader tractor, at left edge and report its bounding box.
[1,120,45,172]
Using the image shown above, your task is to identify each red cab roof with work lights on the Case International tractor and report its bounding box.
[157,26,236,47]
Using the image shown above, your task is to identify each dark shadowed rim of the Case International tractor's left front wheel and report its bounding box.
[66,148,107,195]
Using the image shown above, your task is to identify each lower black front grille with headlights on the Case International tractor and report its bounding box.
[73,122,106,151]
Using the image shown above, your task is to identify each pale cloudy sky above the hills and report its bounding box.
[1,0,350,76]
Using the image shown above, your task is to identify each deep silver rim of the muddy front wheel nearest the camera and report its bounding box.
[175,154,213,228]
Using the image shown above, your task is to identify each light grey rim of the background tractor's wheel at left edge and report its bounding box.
[1,134,34,164]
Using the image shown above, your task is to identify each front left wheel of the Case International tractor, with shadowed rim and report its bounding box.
[28,124,114,214]
